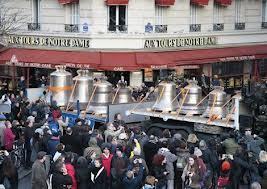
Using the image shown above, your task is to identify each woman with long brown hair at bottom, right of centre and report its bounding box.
[182,155,201,189]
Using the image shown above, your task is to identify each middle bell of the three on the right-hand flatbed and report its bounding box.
[180,80,204,114]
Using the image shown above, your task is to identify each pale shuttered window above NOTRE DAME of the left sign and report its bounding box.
[65,3,80,32]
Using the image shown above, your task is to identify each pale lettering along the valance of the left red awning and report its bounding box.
[6,61,92,69]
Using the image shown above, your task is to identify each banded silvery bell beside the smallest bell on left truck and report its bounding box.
[88,79,112,115]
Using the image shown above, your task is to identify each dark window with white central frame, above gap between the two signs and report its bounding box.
[108,5,127,32]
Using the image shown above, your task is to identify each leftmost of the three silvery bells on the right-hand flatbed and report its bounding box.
[152,81,178,112]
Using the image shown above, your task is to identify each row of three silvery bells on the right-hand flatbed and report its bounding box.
[152,80,226,118]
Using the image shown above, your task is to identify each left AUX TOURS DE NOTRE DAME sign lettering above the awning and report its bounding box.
[7,35,90,48]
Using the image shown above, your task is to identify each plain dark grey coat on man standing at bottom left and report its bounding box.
[32,160,47,189]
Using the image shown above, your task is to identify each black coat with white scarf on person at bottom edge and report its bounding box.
[90,167,108,189]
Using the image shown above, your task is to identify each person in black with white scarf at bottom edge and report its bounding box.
[90,159,110,189]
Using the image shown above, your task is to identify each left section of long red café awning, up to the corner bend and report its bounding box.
[0,49,100,69]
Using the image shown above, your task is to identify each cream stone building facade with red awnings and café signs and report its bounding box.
[0,0,267,87]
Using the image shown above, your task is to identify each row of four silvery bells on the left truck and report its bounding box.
[49,66,132,114]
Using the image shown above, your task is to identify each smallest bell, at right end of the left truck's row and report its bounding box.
[114,87,133,104]
